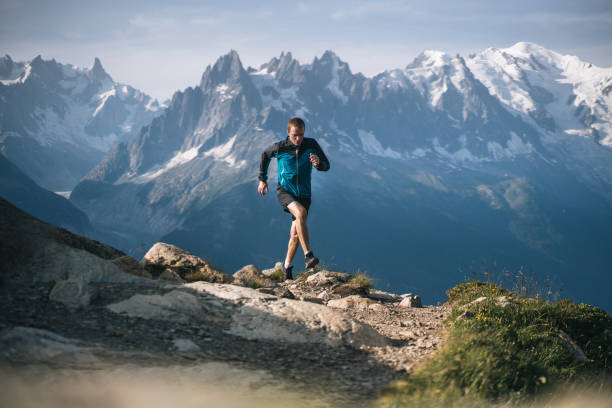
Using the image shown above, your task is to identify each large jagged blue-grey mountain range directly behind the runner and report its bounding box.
[0,43,612,310]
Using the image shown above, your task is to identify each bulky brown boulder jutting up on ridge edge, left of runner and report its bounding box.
[140,242,232,283]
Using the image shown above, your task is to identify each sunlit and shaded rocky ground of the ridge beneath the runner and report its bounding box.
[0,198,448,407]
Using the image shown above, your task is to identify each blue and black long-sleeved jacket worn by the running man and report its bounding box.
[259,137,329,198]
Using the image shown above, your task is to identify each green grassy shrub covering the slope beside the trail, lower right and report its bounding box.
[379,281,612,407]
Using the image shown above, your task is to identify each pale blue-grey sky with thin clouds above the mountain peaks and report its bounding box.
[0,0,612,101]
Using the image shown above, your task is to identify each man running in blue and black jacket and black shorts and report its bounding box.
[257,118,329,279]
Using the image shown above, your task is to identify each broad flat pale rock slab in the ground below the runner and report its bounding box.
[185,282,387,347]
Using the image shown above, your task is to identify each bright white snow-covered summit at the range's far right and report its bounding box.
[466,42,612,147]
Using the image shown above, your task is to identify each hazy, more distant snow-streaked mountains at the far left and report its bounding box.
[0,55,162,191]
